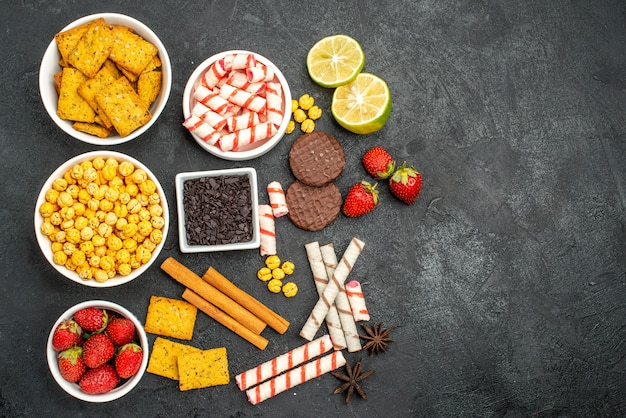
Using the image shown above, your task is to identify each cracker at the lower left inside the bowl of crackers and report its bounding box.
[57,67,96,123]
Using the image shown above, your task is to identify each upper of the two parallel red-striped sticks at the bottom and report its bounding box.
[235,334,332,390]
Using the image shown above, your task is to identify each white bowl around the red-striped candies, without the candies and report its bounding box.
[183,50,291,161]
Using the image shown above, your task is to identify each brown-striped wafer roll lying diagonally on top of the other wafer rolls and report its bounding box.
[300,238,365,347]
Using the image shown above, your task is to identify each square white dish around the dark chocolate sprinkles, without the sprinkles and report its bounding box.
[176,167,261,253]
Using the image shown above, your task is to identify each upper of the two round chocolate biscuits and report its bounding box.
[289,131,346,187]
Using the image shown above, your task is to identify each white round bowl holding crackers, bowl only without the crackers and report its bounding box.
[39,13,172,146]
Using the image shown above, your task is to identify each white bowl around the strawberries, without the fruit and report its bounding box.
[46,300,150,402]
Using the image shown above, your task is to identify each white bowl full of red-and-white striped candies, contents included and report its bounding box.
[183,50,291,161]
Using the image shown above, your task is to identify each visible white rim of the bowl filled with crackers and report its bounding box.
[39,13,172,146]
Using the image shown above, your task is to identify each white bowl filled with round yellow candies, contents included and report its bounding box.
[34,151,169,287]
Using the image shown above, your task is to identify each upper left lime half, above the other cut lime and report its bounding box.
[306,35,365,88]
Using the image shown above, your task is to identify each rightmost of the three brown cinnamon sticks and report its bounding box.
[202,267,289,334]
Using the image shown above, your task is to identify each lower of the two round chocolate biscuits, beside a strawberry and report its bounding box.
[285,180,342,231]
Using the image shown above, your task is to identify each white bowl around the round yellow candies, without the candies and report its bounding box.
[35,151,169,287]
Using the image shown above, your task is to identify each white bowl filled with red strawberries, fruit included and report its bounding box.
[46,300,148,402]
